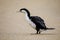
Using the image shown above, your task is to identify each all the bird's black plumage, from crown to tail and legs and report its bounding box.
[20,8,54,34]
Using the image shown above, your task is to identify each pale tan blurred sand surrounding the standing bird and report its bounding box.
[0,0,60,40]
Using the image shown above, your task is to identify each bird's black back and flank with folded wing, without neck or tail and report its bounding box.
[31,16,46,29]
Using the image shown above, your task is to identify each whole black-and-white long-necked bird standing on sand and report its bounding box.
[19,8,55,34]
